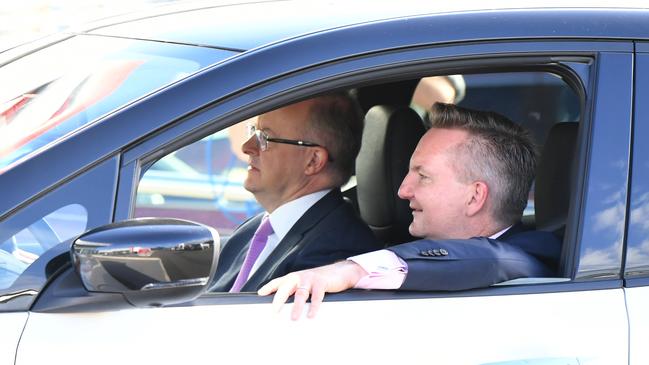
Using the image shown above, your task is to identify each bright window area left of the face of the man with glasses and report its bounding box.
[134,121,262,236]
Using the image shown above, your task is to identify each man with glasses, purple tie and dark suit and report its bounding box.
[211,93,380,292]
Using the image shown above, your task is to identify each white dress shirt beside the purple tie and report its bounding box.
[248,189,331,278]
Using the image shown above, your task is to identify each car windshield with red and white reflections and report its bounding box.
[0,36,234,173]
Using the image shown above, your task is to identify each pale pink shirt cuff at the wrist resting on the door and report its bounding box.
[348,250,408,289]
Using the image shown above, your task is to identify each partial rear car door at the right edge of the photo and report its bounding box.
[625,42,649,364]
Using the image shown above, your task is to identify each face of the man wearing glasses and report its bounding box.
[242,101,311,211]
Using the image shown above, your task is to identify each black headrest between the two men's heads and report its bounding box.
[356,105,426,244]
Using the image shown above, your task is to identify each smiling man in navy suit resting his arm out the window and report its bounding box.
[258,103,560,319]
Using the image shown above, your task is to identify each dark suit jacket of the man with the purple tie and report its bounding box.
[210,189,382,291]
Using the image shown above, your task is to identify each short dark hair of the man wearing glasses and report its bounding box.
[307,92,364,186]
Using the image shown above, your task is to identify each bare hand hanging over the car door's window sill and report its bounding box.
[257,260,367,321]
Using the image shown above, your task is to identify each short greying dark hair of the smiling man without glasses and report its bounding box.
[430,103,538,224]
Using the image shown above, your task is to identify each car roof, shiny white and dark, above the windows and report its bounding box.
[80,0,649,51]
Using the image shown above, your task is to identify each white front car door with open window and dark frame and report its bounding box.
[16,19,633,365]
